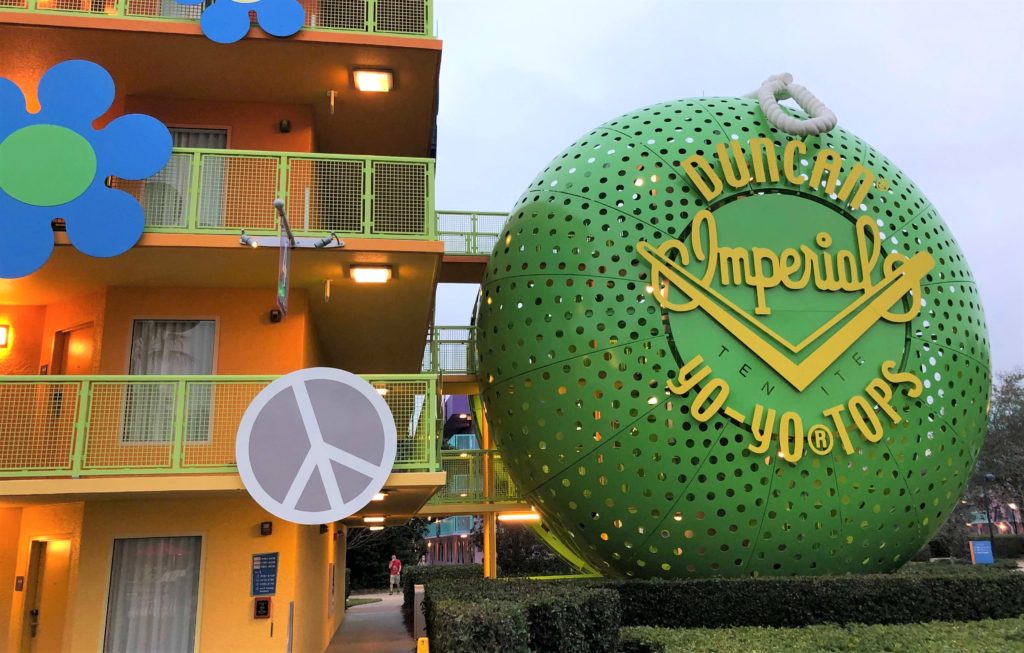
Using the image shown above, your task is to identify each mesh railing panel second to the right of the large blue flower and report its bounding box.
[193,155,281,230]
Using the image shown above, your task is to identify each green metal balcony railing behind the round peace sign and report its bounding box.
[0,375,439,478]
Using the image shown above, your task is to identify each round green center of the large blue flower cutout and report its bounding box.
[0,125,96,207]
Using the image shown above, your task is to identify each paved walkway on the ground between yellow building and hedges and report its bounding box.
[326,593,416,653]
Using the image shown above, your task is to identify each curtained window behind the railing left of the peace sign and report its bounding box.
[121,319,216,442]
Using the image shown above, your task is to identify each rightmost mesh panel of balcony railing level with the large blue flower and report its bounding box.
[373,161,428,233]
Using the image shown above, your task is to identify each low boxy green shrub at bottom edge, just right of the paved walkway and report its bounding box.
[428,599,529,653]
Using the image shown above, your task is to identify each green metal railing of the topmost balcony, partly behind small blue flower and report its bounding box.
[0,0,434,38]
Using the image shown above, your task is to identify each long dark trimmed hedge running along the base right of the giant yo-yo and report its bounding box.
[595,572,1024,628]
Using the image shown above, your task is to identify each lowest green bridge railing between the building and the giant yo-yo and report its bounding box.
[428,449,522,506]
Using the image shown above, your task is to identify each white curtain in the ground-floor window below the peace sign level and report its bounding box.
[103,536,202,653]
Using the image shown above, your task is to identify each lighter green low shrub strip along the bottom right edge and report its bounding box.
[621,618,1024,653]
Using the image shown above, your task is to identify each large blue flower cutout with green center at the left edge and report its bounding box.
[0,60,171,278]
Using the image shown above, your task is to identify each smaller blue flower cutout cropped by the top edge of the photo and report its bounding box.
[177,0,306,43]
